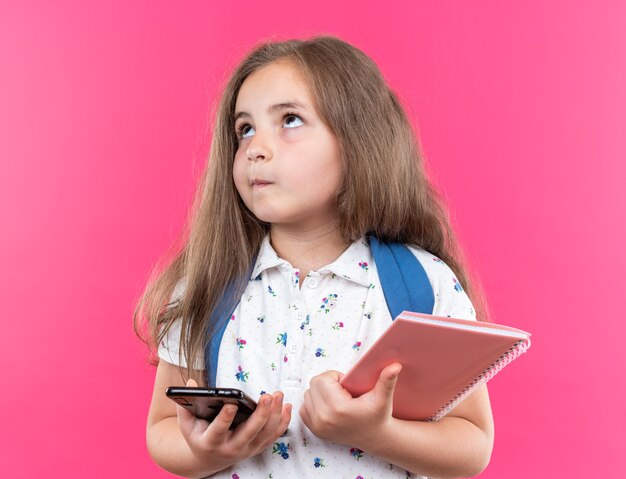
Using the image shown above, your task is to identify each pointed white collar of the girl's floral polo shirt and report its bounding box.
[250,234,373,286]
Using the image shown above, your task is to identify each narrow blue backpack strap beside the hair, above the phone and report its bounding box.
[204,257,256,387]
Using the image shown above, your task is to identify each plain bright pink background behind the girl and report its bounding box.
[0,1,626,478]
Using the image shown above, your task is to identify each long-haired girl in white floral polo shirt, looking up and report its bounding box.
[135,37,493,479]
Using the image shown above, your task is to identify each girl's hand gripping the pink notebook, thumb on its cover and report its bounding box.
[300,363,402,450]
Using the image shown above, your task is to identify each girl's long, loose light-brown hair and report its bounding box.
[134,36,487,382]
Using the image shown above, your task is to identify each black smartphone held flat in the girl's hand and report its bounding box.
[165,387,256,429]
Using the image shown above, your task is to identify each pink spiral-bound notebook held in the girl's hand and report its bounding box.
[341,311,530,421]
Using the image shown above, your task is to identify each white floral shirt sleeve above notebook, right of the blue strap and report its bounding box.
[407,245,476,320]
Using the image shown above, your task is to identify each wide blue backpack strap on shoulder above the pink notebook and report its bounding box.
[369,236,435,319]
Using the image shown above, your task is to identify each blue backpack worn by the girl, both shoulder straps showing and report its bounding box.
[205,236,435,387]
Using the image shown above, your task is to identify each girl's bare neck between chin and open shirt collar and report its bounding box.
[270,224,348,284]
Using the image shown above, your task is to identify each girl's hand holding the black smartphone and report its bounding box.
[176,379,291,472]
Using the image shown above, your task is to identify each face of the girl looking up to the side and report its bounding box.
[233,62,342,233]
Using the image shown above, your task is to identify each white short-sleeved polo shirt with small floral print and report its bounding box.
[158,235,476,479]
